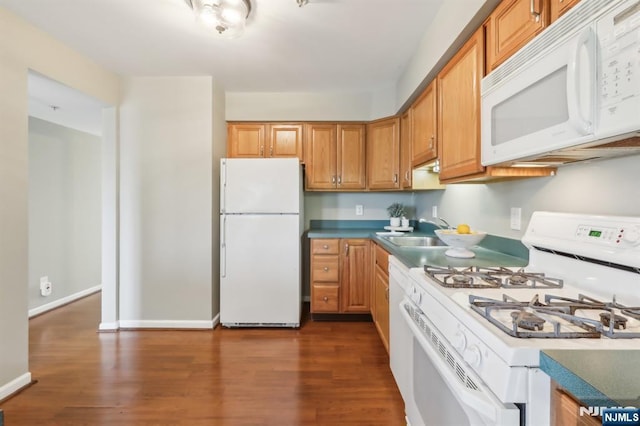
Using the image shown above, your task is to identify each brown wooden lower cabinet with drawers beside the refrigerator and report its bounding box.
[310,238,371,314]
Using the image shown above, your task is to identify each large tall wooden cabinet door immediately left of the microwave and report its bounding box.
[437,29,484,181]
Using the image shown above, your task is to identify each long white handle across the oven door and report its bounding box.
[400,300,520,425]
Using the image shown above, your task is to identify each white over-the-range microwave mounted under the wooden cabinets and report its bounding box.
[481,0,640,166]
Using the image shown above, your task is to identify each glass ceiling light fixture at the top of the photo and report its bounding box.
[185,0,251,38]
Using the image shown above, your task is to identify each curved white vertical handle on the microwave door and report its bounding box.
[567,27,595,135]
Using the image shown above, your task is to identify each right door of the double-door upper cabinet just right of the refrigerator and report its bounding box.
[336,124,366,189]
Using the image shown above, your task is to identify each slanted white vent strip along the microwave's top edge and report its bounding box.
[482,0,611,91]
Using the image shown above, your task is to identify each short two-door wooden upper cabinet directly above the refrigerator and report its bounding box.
[227,123,303,161]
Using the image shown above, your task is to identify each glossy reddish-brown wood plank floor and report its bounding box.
[0,294,404,426]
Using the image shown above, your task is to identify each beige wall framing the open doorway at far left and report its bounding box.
[0,8,120,399]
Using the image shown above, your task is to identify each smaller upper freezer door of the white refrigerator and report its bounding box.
[220,158,302,214]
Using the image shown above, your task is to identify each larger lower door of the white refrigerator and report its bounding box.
[220,215,301,327]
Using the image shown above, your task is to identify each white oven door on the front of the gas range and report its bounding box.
[400,299,520,426]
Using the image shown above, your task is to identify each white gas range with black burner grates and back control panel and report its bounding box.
[391,212,640,426]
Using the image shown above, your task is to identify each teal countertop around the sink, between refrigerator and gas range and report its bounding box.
[306,220,529,268]
